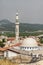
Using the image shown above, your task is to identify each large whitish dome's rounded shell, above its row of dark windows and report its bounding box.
[21,38,38,47]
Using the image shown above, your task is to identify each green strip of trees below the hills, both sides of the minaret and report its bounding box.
[0,31,43,37]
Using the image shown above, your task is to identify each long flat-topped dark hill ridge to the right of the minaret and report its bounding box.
[20,23,43,32]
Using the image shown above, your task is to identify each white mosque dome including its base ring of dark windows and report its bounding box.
[20,38,38,51]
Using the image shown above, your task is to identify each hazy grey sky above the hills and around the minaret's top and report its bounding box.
[0,0,43,24]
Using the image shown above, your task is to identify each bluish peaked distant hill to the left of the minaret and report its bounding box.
[0,20,15,31]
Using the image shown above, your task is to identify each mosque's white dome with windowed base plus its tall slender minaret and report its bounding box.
[15,13,38,51]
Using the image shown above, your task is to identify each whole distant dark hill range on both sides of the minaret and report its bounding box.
[0,20,43,32]
